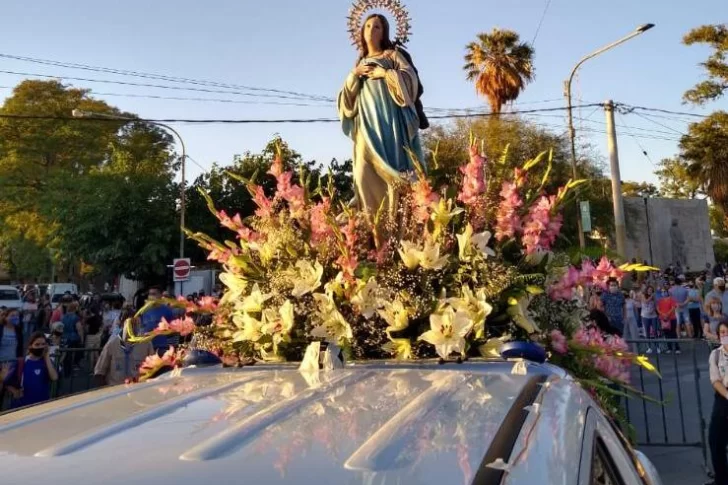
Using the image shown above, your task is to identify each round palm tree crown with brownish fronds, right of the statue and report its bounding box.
[463,29,534,114]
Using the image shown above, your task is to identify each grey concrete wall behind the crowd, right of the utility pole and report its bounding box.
[624,197,715,271]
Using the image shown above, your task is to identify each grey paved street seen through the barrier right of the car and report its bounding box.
[627,342,713,485]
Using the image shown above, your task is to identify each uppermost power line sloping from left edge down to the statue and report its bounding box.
[0,53,333,101]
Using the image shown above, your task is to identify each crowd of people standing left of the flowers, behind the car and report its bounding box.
[0,288,216,409]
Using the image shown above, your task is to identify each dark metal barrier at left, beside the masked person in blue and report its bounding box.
[0,348,101,413]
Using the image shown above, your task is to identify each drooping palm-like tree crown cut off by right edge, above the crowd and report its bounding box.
[680,111,728,213]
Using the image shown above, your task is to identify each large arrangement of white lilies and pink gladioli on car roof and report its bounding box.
[127,143,660,432]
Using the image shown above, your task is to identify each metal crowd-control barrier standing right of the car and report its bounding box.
[624,339,713,470]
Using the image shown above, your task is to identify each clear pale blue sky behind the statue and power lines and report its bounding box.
[0,0,728,186]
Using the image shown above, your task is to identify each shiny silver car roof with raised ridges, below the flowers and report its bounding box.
[0,361,585,485]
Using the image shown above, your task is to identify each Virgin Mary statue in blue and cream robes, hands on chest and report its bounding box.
[338,14,424,221]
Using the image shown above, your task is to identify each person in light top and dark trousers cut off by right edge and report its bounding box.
[708,322,728,485]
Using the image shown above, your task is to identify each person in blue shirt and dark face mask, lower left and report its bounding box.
[8,332,58,408]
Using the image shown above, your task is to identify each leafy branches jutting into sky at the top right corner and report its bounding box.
[683,24,728,104]
